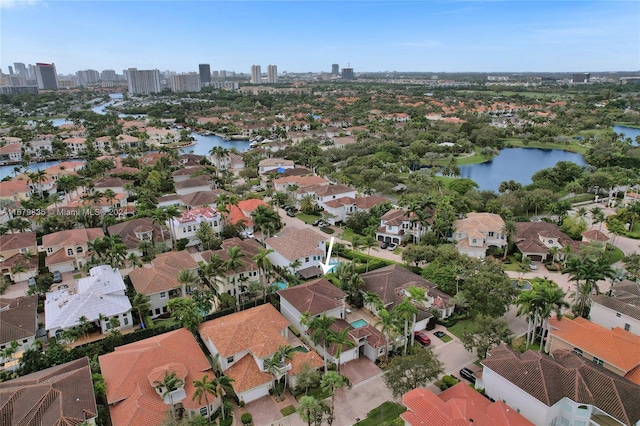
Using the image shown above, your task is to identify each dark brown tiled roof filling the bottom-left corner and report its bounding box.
[0,357,98,426]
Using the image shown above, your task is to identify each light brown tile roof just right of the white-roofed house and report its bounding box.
[129,250,198,295]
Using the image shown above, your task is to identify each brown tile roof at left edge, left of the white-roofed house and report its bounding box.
[0,296,38,344]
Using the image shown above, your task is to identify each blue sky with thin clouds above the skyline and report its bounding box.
[0,0,640,73]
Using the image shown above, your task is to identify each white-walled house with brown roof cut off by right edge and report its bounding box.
[589,280,640,336]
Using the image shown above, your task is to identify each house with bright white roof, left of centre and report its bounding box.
[44,265,133,334]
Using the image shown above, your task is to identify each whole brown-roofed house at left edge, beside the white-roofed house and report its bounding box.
[0,296,38,370]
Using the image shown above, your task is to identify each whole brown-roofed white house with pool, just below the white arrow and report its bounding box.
[278,278,386,364]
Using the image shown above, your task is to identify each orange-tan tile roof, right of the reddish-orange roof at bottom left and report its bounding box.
[199,304,289,363]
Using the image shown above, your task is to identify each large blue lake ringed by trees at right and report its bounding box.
[460,148,587,192]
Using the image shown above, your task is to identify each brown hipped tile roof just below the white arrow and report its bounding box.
[278,278,346,316]
